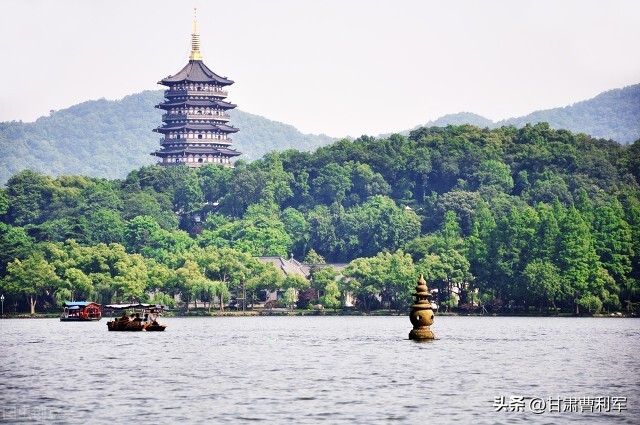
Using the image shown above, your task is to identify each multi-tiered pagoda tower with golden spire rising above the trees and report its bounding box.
[151,10,240,167]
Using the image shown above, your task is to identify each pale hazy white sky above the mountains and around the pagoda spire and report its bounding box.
[0,0,640,136]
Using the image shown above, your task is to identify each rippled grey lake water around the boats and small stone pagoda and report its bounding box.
[0,316,640,424]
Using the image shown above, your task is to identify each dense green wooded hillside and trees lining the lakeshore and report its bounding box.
[0,123,640,313]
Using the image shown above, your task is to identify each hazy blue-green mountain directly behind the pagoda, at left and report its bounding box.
[0,90,335,184]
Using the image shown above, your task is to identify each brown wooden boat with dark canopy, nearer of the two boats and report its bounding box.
[105,303,167,332]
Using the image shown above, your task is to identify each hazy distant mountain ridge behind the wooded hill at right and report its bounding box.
[402,84,640,144]
